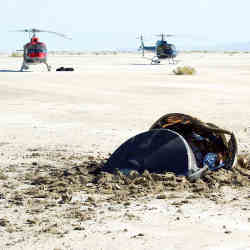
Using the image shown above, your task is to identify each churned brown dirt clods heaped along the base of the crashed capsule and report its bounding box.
[21,152,250,203]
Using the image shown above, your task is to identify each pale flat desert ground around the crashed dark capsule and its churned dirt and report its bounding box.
[0,53,250,250]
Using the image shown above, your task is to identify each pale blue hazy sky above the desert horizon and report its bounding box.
[0,0,250,51]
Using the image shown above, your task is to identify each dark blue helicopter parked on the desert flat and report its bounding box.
[139,34,177,64]
